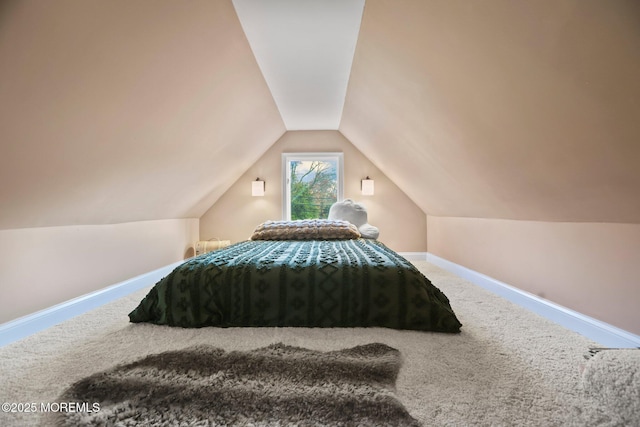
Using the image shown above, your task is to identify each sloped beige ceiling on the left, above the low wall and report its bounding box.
[0,0,285,229]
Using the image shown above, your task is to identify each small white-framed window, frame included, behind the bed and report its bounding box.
[282,153,343,220]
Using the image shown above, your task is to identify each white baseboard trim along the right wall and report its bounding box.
[426,253,640,348]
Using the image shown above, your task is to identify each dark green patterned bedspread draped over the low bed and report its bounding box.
[129,239,461,332]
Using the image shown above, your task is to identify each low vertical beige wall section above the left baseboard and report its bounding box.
[0,219,198,323]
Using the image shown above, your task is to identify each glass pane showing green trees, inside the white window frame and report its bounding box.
[289,160,338,220]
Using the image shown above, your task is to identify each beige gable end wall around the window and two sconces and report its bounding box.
[200,131,427,252]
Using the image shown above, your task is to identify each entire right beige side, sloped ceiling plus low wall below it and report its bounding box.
[339,0,640,340]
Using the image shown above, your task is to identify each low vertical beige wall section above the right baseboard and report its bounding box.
[427,216,640,334]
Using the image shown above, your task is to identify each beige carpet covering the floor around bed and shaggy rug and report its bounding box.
[0,262,640,426]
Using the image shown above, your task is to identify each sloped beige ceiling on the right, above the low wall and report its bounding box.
[340,0,640,223]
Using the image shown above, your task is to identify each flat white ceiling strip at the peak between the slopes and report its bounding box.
[233,0,364,130]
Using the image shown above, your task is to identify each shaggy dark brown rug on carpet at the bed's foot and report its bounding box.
[52,343,420,426]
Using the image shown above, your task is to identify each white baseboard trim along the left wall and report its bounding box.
[0,261,184,347]
